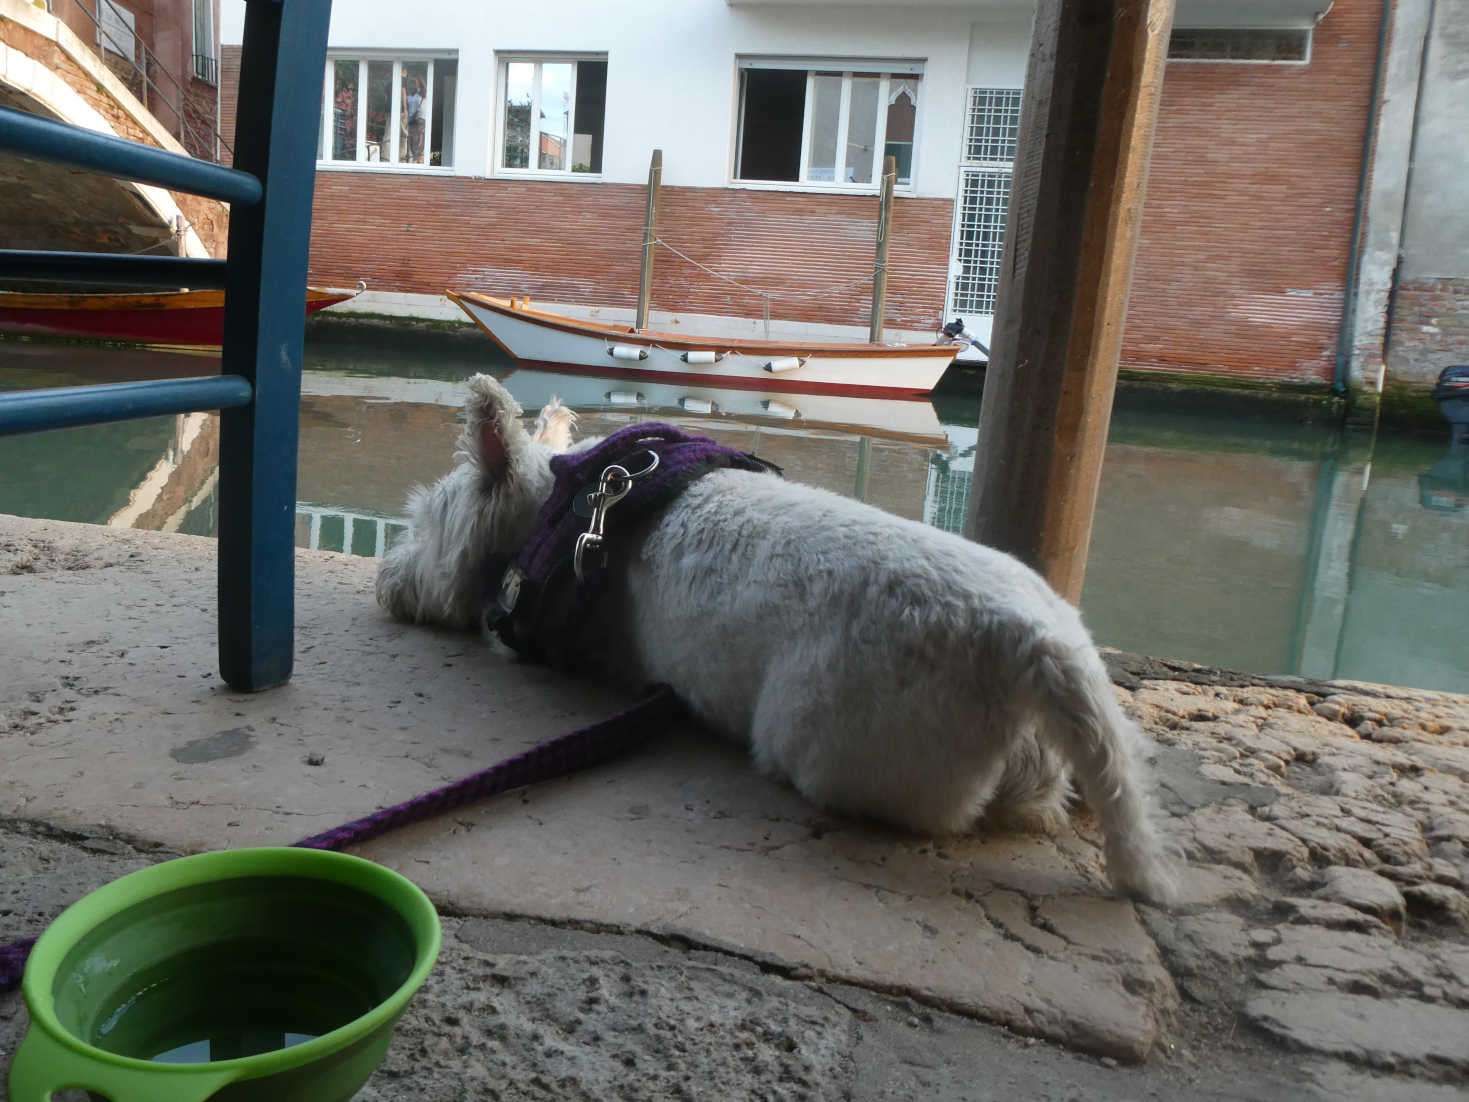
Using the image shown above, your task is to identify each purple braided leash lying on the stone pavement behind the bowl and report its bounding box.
[0,685,682,990]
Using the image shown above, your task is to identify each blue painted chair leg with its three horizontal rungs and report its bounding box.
[0,0,331,692]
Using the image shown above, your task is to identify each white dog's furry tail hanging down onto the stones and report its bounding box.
[1025,633,1177,902]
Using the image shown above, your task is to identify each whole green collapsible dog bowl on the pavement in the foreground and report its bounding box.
[10,849,439,1102]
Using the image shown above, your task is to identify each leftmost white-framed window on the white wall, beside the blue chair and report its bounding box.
[317,56,458,168]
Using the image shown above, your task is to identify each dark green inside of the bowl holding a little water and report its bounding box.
[57,877,414,1064]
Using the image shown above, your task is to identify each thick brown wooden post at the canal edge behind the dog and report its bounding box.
[965,0,1174,602]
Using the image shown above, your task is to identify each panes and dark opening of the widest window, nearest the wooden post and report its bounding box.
[735,60,923,191]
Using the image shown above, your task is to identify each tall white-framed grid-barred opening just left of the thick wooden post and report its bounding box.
[948,88,1021,316]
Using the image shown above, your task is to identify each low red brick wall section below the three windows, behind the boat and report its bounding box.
[311,170,953,335]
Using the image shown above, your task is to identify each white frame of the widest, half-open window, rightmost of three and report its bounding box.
[726,54,927,195]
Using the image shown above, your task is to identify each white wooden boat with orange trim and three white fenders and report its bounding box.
[447,291,962,398]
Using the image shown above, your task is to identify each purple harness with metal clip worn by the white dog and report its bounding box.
[485,422,780,670]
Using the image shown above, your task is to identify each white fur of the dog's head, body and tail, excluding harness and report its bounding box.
[378,375,1172,901]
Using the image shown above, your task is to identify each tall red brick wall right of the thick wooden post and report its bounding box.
[1122,0,1382,382]
